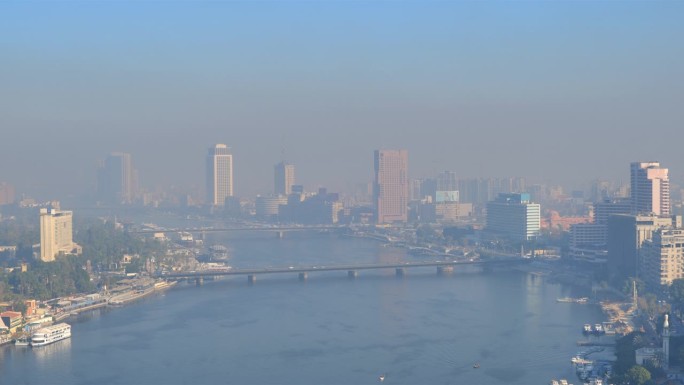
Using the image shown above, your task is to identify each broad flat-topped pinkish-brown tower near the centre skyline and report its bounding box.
[373,150,409,223]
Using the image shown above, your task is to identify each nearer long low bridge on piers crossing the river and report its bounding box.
[155,257,531,284]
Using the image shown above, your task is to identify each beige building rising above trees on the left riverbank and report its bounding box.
[40,209,79,262]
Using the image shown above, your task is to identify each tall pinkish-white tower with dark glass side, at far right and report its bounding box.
[630,162,670,216]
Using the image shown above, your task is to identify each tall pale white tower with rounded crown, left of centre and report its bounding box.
[207,144,233,206]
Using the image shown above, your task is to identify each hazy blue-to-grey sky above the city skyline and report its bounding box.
[0,0,684,199]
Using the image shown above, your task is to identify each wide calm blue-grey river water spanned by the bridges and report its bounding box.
[0,233,603,385]
